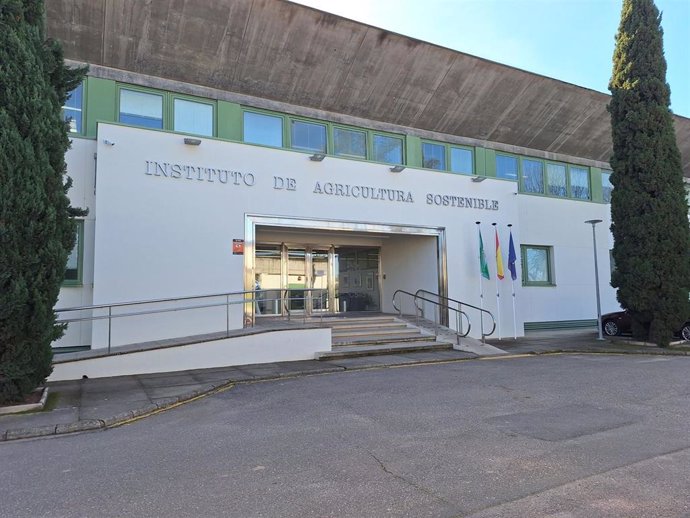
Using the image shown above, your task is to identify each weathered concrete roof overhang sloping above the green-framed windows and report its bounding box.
[46,0,690,177]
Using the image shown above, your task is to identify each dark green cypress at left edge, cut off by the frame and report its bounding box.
[0,0,85,404]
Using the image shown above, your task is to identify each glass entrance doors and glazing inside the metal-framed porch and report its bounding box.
[254,243,381,316]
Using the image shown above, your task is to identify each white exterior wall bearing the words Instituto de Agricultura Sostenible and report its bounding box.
[60,123,617,348]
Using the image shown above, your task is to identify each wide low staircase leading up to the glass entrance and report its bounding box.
[317,315,453,360]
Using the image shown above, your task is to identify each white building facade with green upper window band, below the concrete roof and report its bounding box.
[45,5,636,349]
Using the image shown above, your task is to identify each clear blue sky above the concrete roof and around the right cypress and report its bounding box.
[292,0,690,118]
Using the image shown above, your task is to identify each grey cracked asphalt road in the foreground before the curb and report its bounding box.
[0,355,690,518]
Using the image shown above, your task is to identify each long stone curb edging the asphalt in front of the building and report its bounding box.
[0,347,690,442]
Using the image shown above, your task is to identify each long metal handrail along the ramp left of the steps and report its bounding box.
[55,288,328,353]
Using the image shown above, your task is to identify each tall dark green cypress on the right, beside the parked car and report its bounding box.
[609,0,690,346]
